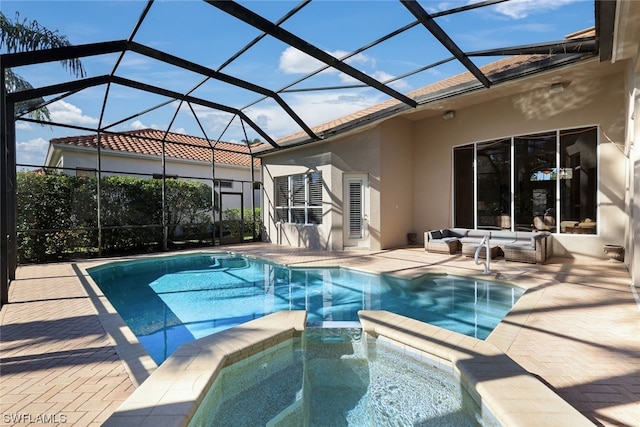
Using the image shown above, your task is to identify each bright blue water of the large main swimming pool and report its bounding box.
[88,253,523,364]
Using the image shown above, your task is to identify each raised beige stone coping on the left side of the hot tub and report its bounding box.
[103,310,307,427]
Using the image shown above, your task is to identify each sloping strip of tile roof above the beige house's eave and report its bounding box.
[270,28,596,151]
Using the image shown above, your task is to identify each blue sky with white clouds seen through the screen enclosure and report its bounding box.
[0,0,594,169]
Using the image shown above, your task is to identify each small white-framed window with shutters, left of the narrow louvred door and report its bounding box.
[274,172,322,224]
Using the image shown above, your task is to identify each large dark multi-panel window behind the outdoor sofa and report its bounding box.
[453,127,598,234]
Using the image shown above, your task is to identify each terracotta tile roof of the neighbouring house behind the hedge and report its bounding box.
[50,129,260,167]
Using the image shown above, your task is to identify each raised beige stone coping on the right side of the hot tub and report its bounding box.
[358,310,594,427]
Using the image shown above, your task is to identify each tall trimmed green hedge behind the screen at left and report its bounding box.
[16,172,217,262]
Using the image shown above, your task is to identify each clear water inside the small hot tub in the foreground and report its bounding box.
[190,328,486,427]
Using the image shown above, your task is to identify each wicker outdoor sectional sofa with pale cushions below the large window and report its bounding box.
[424,228,550,264]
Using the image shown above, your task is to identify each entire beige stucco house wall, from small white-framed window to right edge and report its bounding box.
[263,57,630,258]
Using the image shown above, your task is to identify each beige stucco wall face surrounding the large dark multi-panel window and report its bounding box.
[413,65,627,257]
